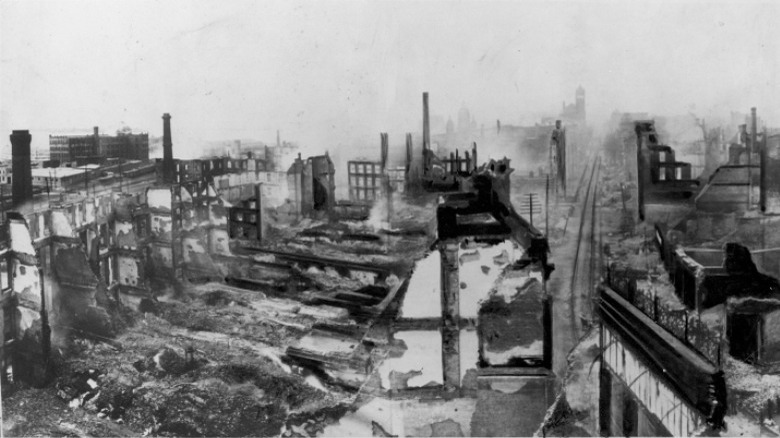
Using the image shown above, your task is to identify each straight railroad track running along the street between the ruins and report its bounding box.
[569,157,601,343]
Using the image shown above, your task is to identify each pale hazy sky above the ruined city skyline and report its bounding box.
[0,0,780,156]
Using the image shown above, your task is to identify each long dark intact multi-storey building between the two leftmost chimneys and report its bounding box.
[49,126,149,163]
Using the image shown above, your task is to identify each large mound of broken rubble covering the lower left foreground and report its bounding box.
[6,276,366,436]
